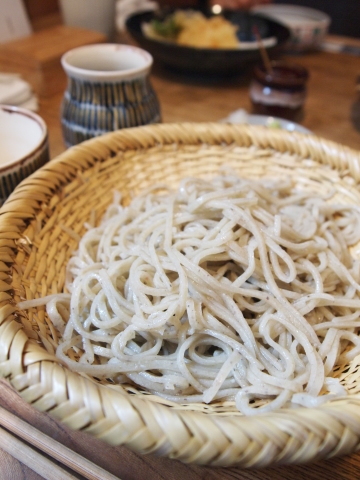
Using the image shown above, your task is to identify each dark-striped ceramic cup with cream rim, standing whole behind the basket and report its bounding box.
[61,44,161,147]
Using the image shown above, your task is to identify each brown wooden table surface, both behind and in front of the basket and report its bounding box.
[0,27,360,480]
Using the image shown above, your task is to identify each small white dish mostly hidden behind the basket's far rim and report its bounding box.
[221,109,311,133]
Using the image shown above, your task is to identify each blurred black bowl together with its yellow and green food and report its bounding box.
[126,10,290,74]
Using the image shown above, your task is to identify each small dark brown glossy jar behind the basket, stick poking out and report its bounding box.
[250,61,309,121]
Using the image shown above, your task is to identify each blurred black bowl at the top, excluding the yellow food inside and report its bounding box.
[126,10,290,75]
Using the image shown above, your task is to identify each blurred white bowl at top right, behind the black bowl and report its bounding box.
[252,4,331,52]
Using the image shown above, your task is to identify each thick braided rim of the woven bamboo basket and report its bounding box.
[0,123,360,467]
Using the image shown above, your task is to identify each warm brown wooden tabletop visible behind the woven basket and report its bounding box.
[39,32,360,157]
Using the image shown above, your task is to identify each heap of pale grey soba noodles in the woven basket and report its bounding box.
[20,175,360,415]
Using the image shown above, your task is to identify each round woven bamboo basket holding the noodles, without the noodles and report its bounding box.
[0,124,360,467]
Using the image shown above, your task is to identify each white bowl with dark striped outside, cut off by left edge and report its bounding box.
[0,105,49,205]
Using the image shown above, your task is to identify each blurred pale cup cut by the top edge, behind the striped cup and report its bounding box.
[59,0,116,39]
